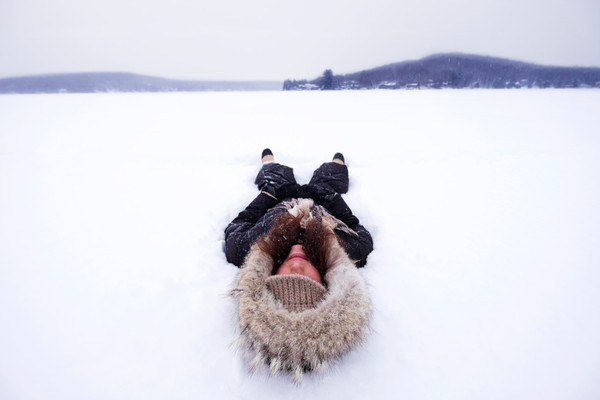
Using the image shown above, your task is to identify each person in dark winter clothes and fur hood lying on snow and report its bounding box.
[225,149,373,382]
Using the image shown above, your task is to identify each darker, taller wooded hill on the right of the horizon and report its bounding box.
[284,53,600,90]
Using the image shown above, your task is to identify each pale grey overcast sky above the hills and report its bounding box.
[0,0,600,80]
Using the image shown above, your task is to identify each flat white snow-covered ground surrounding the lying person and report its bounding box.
[0,90,600,400]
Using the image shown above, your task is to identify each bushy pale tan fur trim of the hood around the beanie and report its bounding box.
[232,199,371,383]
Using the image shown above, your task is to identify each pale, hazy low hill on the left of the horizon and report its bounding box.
[0,72,281,94]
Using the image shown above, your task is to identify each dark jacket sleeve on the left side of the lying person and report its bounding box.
[225,193,279,267]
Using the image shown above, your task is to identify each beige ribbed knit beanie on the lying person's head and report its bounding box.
[266,274,327,312]
